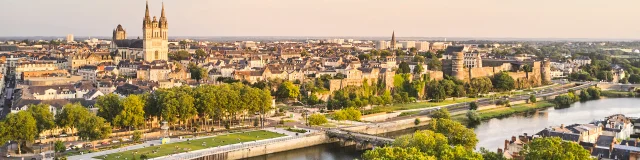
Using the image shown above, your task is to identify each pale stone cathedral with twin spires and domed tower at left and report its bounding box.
[110,2,169,63]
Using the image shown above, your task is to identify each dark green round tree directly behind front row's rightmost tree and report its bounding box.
[96,93,123,122]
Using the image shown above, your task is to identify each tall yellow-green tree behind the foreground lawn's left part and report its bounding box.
[113,94,145,129]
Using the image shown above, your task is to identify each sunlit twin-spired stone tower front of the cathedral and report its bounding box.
[142,1,169,62]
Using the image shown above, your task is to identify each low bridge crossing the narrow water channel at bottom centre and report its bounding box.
[325,129,394,149]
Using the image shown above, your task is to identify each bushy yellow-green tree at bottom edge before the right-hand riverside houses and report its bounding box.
[520,137,591,160]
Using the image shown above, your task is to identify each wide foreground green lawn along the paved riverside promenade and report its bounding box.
[93,130,284,160]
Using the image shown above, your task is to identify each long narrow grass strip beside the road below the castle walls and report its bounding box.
[364,98,478,115]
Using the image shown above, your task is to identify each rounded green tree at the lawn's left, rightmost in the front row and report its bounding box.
[78,115,111,149]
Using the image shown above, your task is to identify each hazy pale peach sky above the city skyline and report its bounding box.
[0,0,640,39]
